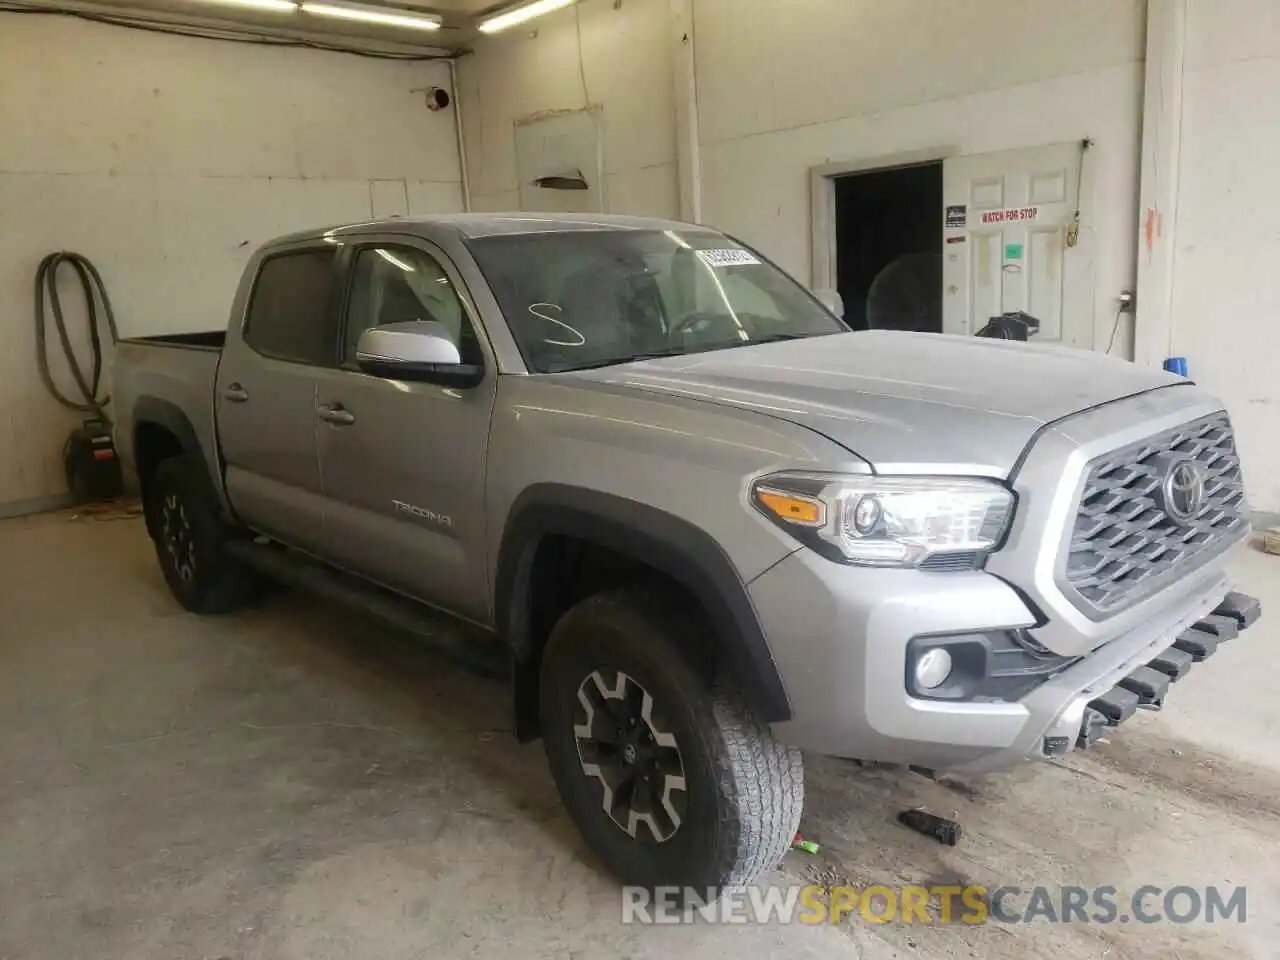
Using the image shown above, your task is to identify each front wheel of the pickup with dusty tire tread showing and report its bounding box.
[539,588,804,896]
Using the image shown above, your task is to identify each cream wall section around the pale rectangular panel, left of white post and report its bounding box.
[458,0,680,216]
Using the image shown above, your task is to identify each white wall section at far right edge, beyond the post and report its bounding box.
[1166,0,1280,512]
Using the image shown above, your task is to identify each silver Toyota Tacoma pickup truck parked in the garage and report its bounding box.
[115,215,1258,888]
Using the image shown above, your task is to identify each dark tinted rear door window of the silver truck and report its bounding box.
[244,250,337,364]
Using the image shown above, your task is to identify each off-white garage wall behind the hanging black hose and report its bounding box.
[0,13,462,512]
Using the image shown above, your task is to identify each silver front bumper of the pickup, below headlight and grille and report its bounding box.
[750,550,1257,773]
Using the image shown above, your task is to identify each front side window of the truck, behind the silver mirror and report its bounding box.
[342,246,484,366]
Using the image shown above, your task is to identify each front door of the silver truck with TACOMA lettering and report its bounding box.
[317,239,497,622]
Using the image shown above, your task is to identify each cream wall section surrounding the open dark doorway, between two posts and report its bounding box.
[694,0,1143,355]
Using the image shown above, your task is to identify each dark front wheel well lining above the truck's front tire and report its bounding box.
[515,535,717,741]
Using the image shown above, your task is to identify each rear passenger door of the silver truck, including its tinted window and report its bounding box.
[214,244,338,553]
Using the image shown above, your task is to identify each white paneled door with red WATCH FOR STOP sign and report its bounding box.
[942,142,1093,347]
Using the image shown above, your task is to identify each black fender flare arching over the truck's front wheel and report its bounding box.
[494,484,791,723]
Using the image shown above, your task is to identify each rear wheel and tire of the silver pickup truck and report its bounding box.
[146,454,253,613]
